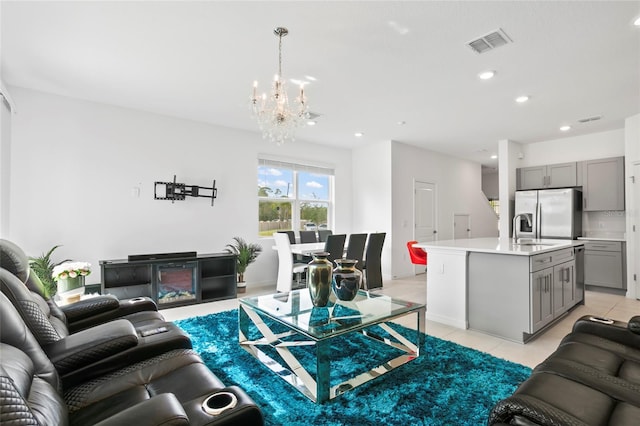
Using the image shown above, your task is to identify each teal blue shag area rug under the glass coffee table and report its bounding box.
[176,310,531,426]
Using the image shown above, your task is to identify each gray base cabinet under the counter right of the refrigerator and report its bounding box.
[584,241,627,290]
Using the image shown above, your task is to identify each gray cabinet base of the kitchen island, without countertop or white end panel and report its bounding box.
[467,247,583,343]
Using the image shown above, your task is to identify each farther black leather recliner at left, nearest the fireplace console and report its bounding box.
[0,240,196,386]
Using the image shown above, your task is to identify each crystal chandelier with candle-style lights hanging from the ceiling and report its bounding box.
[251,27,309,145]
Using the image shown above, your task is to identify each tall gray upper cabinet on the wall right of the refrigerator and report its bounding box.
[582,157,624,211]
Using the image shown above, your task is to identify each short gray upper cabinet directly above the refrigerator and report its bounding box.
[516,162,577,190]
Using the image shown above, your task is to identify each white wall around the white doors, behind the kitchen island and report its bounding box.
[385,142,498,277]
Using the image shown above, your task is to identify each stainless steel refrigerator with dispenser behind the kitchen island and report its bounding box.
[514,188,582,240]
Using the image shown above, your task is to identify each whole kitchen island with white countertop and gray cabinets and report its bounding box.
[414,238,584,343]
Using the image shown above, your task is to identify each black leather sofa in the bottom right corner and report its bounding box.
[488,315,640,426]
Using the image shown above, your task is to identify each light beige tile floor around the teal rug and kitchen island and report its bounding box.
[161,274,640,368]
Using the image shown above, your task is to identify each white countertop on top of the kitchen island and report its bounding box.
[414,238,584,256]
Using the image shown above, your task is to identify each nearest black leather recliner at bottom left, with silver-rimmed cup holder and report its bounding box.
[0,293,263,426]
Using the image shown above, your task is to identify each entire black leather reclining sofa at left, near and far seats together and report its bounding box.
[0,240,264,426]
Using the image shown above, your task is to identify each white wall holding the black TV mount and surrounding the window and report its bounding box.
[6,88,353,286]
